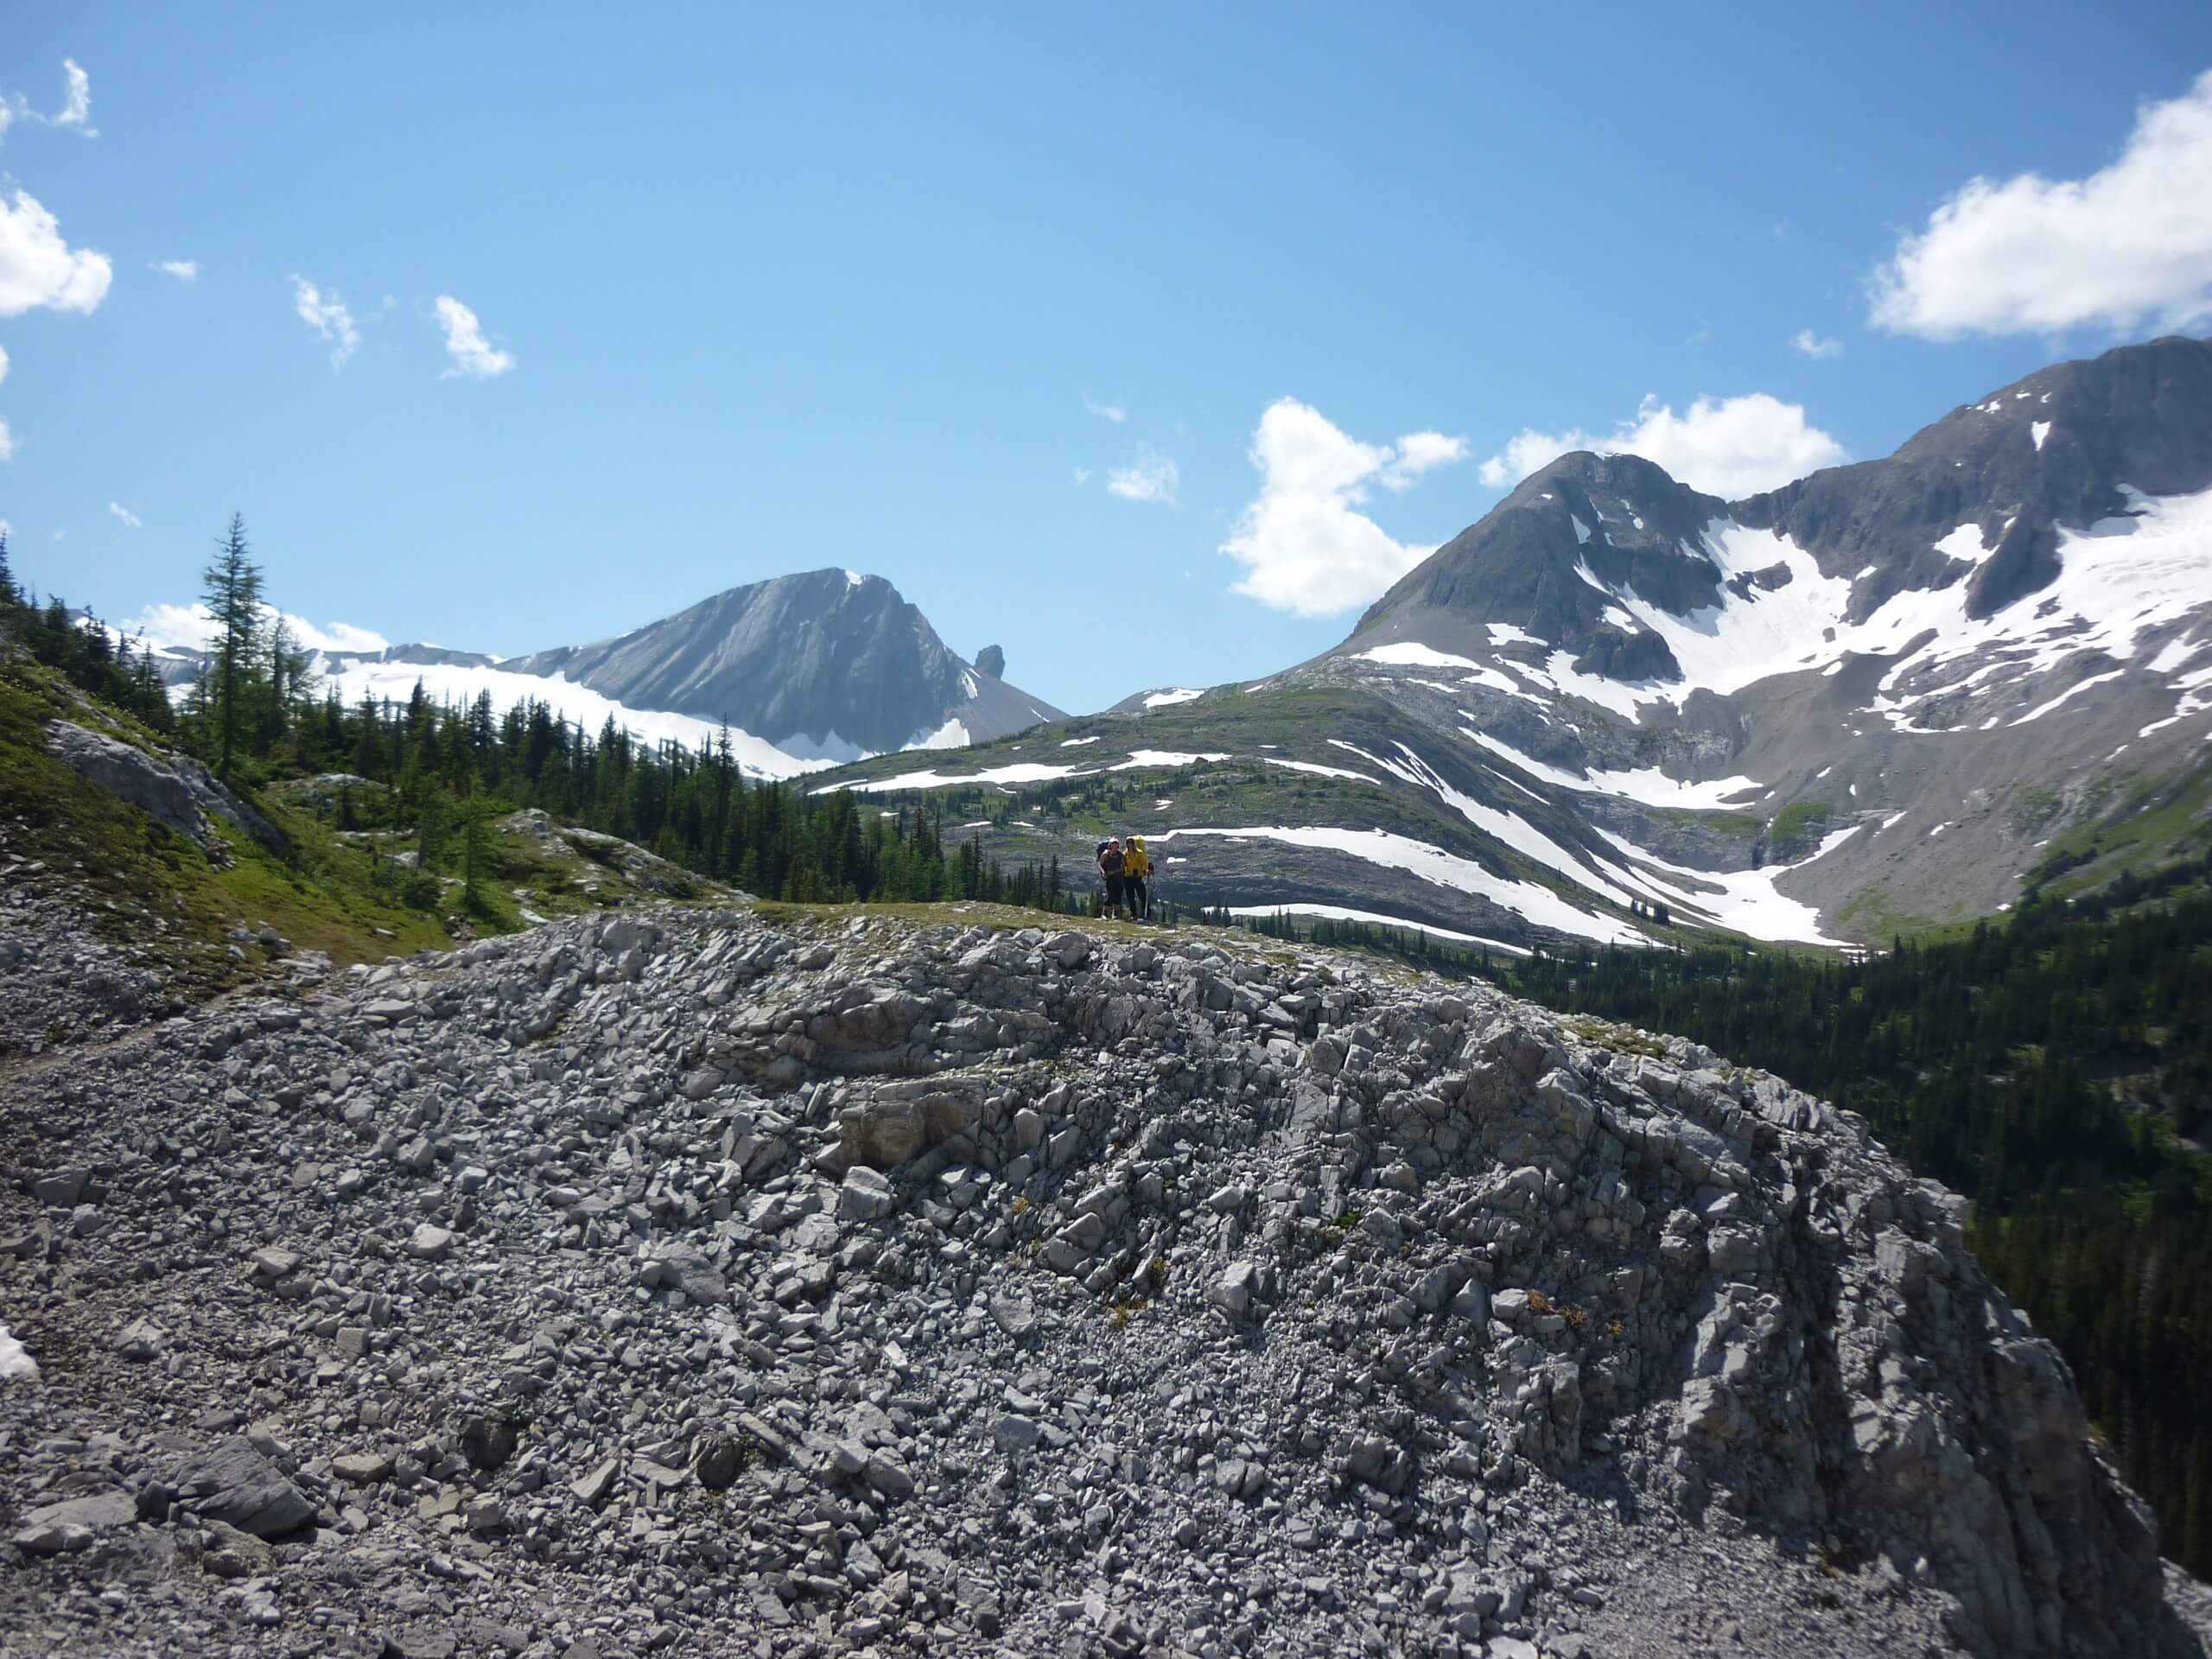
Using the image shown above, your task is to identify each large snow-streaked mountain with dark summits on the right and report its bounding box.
[825,339,2212,947]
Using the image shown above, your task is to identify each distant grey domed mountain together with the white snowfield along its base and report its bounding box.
[129,570,1062,777]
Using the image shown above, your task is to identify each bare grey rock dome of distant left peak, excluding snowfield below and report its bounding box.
[502,570,1062,752]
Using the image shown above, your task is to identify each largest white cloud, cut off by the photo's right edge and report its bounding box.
[1872,71,2212,340]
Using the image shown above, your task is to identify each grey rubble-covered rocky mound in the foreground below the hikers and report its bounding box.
[0,912,2203,1659]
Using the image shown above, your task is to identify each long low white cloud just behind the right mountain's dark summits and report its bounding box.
[1482,391,1849,500]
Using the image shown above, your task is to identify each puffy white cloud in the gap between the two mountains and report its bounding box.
[1221,398,1466,617]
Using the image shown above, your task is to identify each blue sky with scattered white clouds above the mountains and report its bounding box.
[0,4,2212,710]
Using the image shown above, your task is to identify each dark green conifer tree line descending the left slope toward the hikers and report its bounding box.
[0,515,1075,912]
